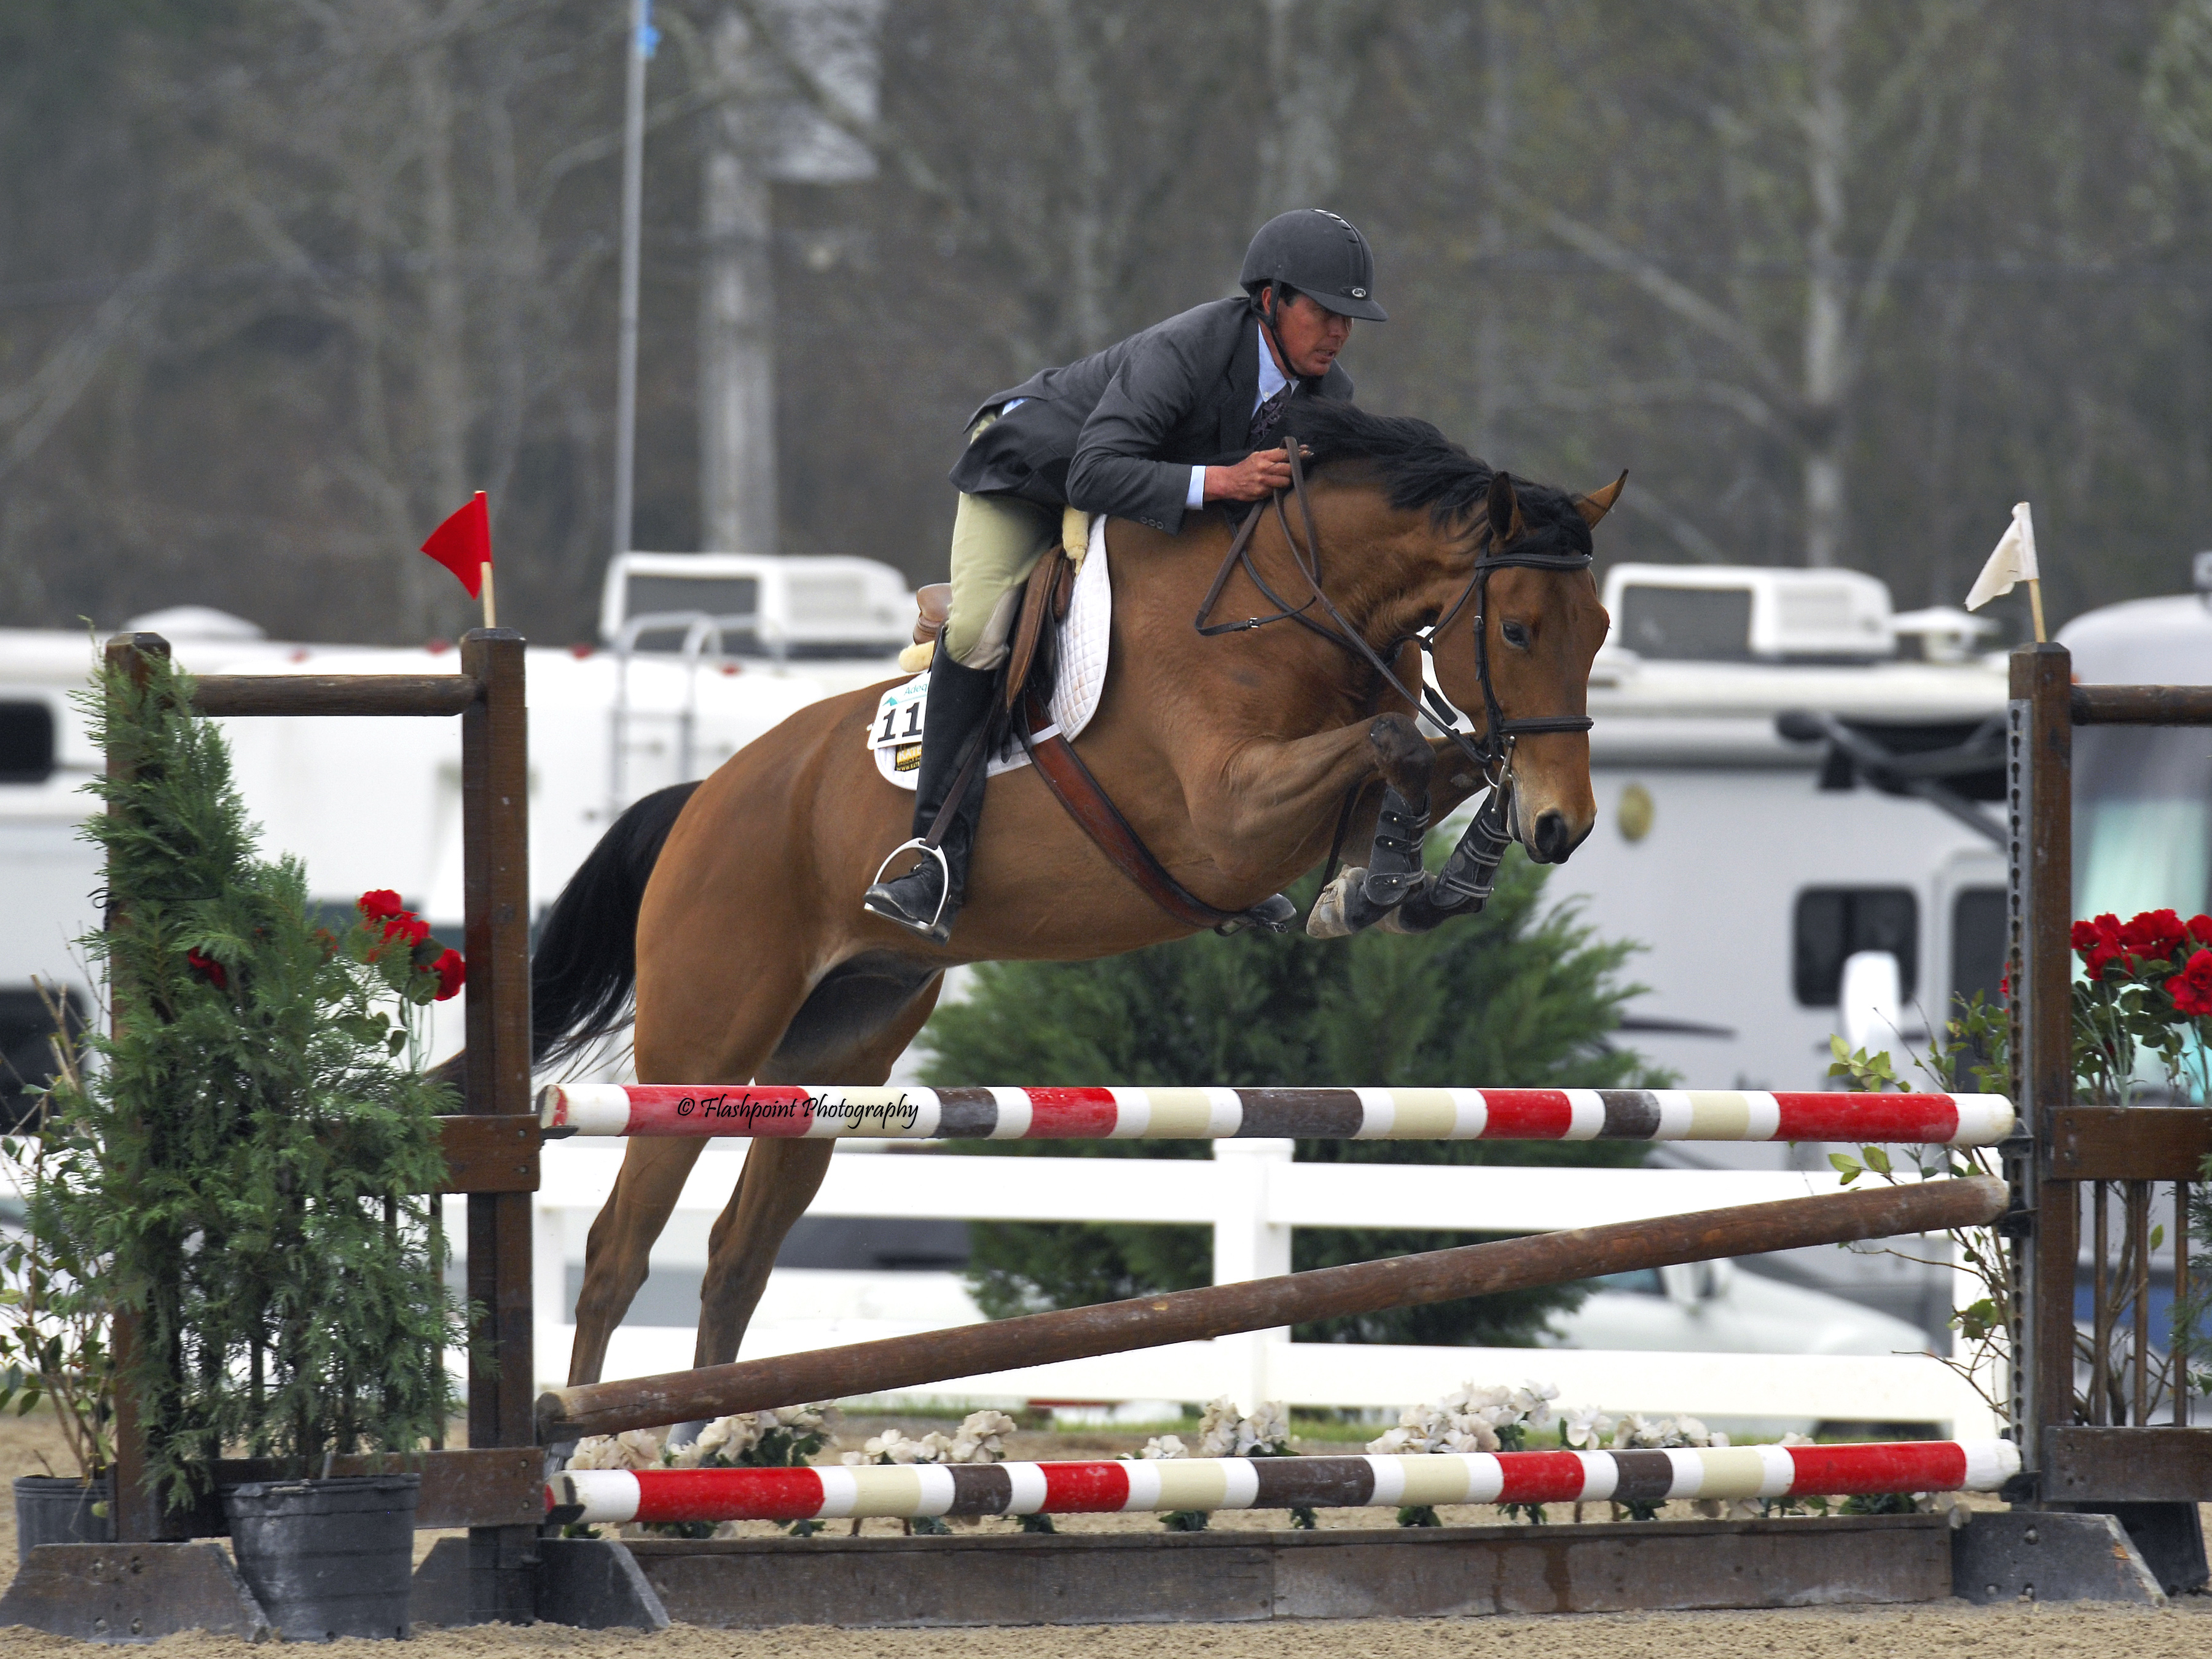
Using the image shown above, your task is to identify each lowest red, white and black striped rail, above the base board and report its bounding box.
[546,1440,2020,1526]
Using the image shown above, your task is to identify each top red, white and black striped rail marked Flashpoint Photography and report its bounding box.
[538,1084,2013,1146]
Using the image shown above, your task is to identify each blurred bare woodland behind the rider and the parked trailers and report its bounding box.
[0,0,2212,641]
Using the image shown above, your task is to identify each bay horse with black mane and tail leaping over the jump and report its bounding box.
[531,402,1619,1406]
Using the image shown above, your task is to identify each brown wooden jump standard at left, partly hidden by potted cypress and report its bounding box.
[106,628,544,1622]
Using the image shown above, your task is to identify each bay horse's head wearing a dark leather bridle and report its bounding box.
[1433,471,1628,865]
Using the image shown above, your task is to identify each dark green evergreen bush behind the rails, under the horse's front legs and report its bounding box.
[922,854,1663,1345]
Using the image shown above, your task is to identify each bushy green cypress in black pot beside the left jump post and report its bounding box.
[33,659,467,1637]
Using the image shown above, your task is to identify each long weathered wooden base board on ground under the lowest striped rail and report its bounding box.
[628,1515,1951,1630]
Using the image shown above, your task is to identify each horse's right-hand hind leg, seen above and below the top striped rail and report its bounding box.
[692,971,943,1365]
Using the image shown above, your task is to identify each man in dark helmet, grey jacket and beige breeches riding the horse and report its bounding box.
[860,208,1387,944]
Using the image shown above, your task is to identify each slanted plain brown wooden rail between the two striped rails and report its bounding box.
[538,1177,2006,1440]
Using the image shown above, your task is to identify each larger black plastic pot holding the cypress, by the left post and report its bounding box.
[224,1475,423,1641]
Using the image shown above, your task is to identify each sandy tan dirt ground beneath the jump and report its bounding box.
[0,1413,2212,1659]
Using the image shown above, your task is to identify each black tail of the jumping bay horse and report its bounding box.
[531,783,699,1066]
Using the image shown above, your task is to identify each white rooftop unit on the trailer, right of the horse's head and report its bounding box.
[1606,564,1898,664]
